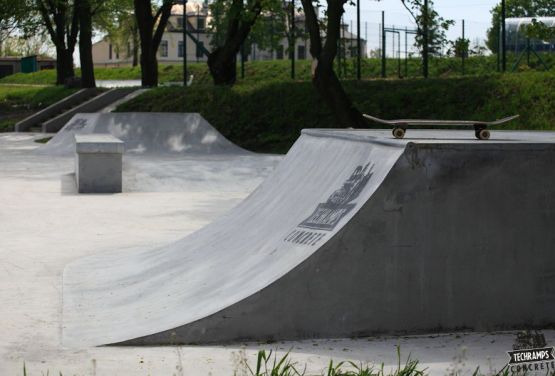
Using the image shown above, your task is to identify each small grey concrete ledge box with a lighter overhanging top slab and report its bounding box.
[75,134,124,193]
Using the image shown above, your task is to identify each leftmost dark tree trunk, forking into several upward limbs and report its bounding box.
[35,0,79,85]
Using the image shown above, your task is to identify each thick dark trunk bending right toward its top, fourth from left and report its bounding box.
[208,0,263,85]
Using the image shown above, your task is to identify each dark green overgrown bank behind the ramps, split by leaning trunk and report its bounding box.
[118,72,555,152]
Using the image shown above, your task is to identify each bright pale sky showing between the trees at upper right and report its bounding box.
[343,0,500,53]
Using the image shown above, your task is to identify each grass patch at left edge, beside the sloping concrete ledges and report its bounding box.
[0,85,77,132]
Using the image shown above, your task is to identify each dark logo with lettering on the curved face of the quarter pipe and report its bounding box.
[284,163,374,246]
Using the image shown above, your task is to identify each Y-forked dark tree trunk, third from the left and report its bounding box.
[133,0,175,87]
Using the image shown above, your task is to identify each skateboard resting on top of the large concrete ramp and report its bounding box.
[362,114,520,140]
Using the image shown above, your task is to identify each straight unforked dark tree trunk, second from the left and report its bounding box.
[76,0,96,88]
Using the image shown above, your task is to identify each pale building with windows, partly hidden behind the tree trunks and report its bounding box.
[93,1,366,67]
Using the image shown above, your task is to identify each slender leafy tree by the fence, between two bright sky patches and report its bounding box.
[401,0,455,56]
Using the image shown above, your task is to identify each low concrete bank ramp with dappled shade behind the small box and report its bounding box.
[35,112,244,156]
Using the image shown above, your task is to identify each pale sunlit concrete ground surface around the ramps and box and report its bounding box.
[0,133,555,376]
